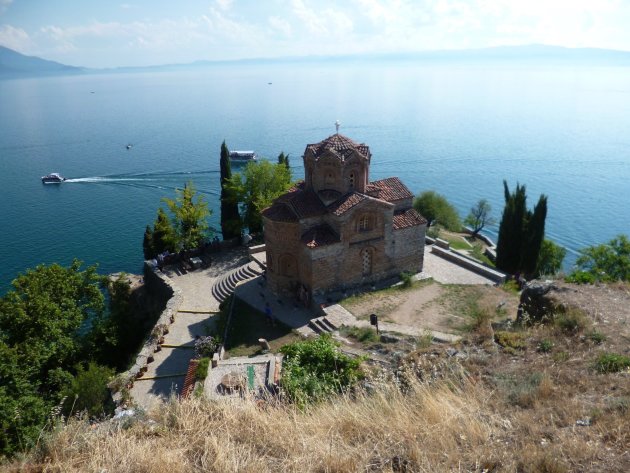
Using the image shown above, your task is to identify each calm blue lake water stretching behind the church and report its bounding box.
[0,63,630,294]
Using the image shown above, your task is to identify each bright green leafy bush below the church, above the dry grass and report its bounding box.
[280,335,363,407]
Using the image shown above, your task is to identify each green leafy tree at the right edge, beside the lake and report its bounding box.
[576,235,630,281]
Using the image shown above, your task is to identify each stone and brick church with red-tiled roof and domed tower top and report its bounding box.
[262,130,427,304]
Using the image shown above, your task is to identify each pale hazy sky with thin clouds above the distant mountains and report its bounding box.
[0,0,630,67]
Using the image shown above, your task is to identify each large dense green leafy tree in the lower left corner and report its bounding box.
[0,260,105,455]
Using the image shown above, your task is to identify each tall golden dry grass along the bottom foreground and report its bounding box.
[8,384,496,473]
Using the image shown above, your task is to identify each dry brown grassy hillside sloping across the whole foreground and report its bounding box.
[5,286,630,473]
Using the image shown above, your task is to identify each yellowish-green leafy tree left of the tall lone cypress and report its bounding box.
[163,181,211,250]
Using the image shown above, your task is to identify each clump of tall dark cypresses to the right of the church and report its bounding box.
[496,181,547,278]
